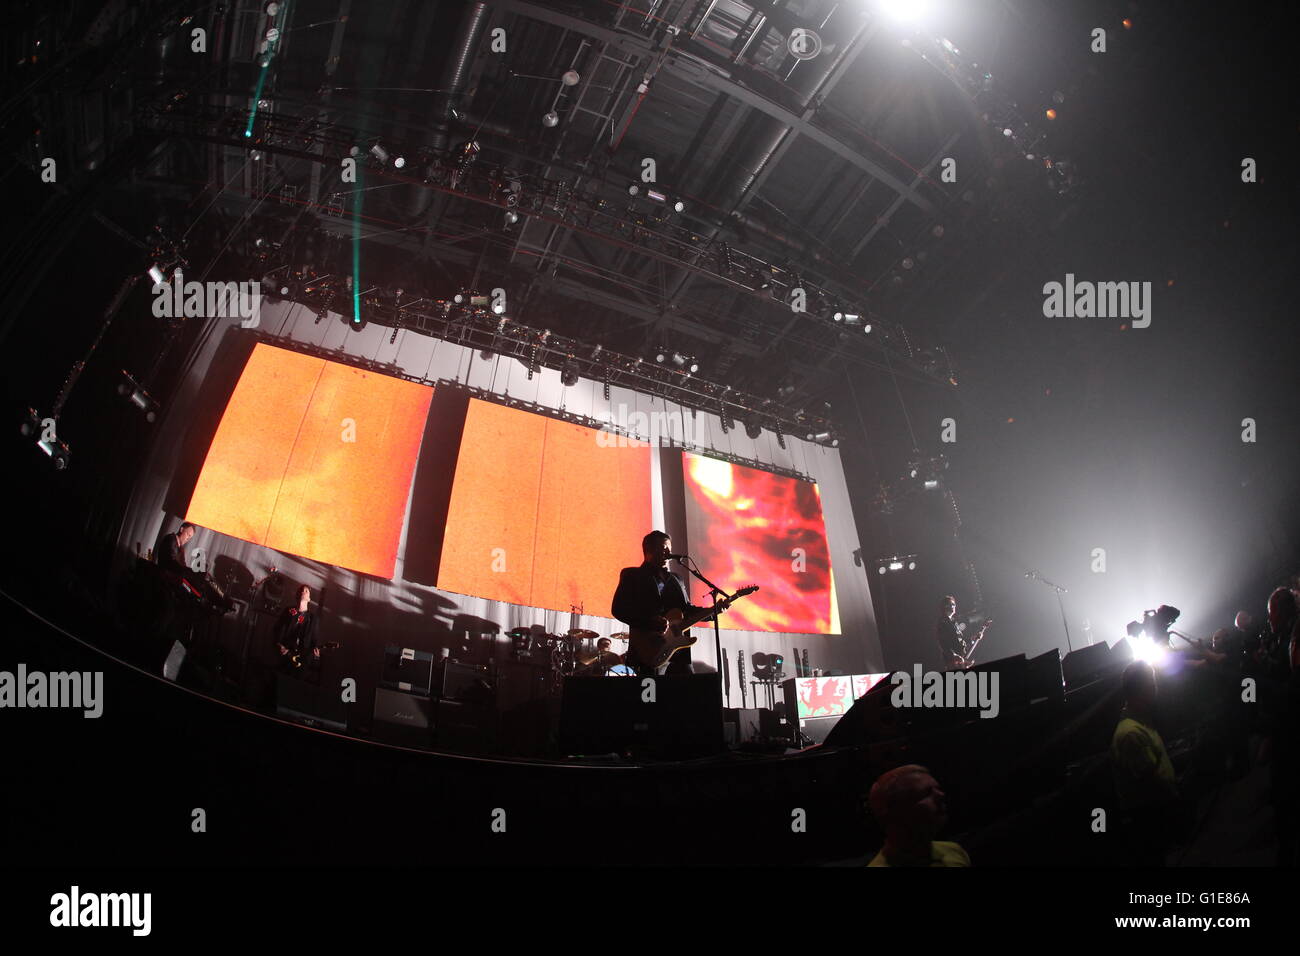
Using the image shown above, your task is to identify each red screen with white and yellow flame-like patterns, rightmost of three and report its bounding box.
[681,453,840,633]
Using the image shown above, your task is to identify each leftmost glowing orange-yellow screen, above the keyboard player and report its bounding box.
[186,343,433,578]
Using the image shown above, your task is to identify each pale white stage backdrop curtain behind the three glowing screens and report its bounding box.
[120,303,883,686]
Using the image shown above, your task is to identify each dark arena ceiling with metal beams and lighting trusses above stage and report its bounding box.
[5,0,1084,429]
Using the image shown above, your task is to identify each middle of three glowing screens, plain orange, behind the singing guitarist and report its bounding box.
[437,399,653,617]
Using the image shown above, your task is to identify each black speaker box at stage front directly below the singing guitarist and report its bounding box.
[560,674,724,760]
